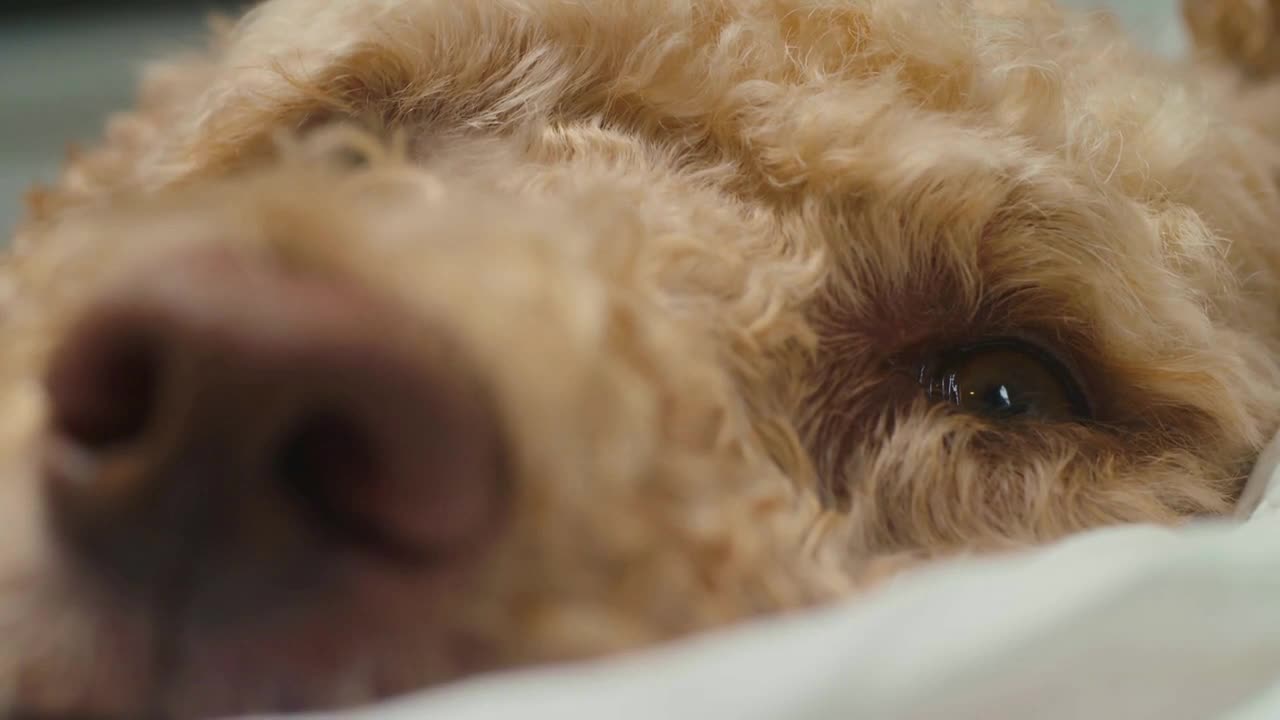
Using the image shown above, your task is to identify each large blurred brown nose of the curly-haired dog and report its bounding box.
[44,251,503,579]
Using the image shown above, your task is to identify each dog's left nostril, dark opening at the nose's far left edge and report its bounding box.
[46,316,163,451]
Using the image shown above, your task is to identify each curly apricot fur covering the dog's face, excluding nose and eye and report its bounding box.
[0,0,1280,716]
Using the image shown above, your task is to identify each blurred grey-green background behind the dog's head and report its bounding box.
[0,0,1184,233]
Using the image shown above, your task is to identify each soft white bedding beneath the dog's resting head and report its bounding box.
[267,425,1280,720]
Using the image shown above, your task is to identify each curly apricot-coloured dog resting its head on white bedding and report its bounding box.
[0,0,1280,717]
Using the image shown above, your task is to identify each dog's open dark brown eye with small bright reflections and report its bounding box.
[920,338,1091,421]
